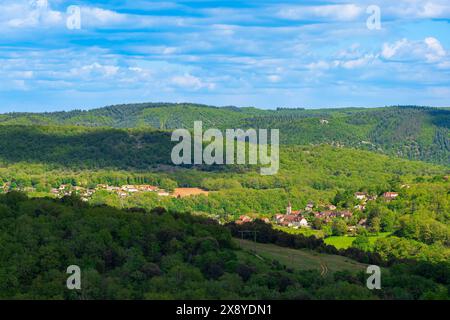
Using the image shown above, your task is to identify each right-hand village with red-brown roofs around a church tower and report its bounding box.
[235,192,399,233]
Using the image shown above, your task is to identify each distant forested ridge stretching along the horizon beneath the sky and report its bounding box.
[0,103,450,165]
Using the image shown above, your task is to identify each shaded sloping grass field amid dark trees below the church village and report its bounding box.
[236,239,367,275]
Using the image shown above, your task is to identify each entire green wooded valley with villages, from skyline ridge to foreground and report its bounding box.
[0,104,450,299]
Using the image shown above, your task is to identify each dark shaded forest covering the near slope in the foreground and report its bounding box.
[0,192,450,299]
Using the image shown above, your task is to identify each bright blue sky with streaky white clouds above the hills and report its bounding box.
[0,0,450,112]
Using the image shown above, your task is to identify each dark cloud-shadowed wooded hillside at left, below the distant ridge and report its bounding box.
[0,125,172,169]
